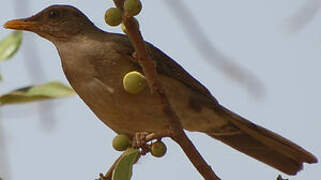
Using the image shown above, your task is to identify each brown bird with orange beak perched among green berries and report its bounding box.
[4,5,317,175]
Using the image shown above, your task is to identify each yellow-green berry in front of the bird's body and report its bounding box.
[123,71,146,94]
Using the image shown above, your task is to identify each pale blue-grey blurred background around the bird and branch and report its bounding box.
[0,0,321,180]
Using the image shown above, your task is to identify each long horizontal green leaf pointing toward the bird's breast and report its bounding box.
[0,81,75,105]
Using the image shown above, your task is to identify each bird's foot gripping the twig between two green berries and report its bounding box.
[133,132,171,155]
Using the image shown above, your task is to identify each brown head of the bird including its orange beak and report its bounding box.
[4,5,95,42]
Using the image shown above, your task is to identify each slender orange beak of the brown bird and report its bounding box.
[3,18,39,31]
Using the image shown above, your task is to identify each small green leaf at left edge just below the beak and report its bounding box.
[0,31,22,62]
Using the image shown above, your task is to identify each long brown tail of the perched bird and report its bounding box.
[206,106,318,175]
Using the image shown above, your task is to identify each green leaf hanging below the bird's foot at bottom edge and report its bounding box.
[112,148,139,180]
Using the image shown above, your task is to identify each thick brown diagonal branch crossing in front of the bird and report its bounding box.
[114,0,219,180]
